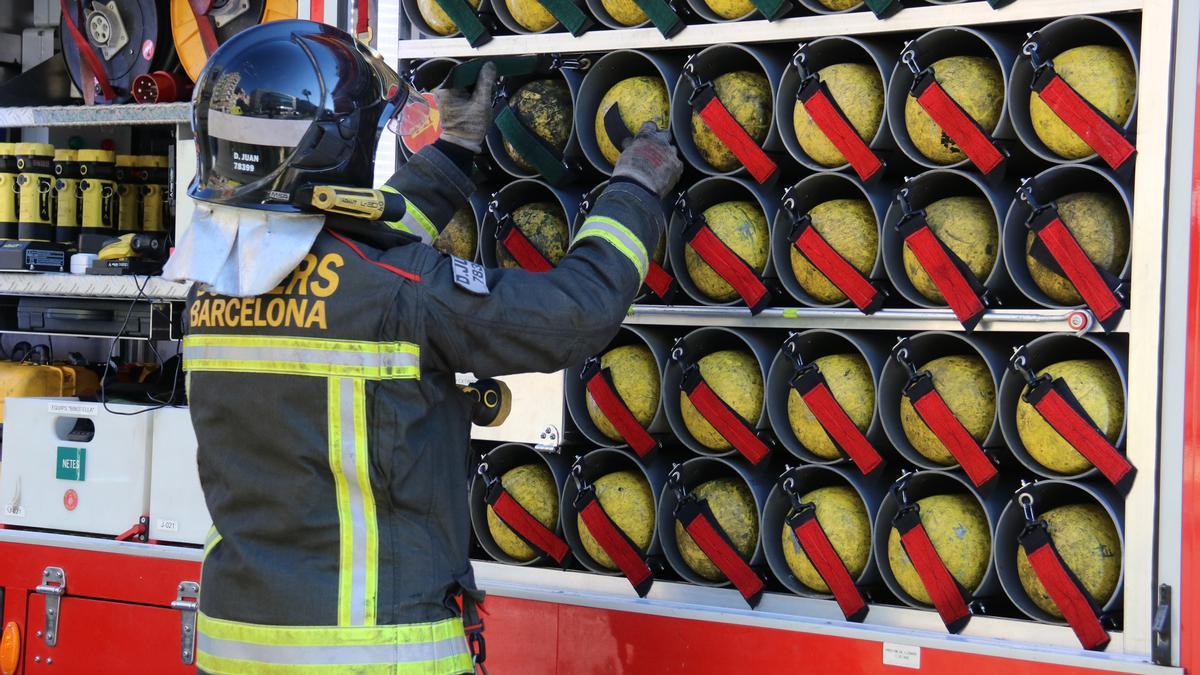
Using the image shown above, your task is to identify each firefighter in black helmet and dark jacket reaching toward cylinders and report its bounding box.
[167,20,683,674]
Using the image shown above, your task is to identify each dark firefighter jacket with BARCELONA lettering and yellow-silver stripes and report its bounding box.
[184,147,664,675]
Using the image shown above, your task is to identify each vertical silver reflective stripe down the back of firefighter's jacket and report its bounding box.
[336,377,371,626]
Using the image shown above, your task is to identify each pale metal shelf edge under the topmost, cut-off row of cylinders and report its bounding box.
[398,0,1144,59]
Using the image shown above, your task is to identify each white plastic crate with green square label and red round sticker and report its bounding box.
[0,399,152,537]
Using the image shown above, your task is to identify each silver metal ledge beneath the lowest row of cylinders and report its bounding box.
[472,560,1181,674]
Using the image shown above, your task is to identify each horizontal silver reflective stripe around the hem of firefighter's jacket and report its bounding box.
[196,633,469,665]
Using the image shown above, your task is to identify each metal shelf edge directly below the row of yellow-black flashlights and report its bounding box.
[0,271,191,300]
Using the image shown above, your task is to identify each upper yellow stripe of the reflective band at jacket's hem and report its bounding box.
[197,611,463,647]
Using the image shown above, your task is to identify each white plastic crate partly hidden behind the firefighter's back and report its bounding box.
[150,408,212,544]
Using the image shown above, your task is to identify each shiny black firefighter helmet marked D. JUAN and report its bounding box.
[187,20,434,211]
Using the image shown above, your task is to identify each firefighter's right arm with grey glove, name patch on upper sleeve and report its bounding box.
[405,119,683,377]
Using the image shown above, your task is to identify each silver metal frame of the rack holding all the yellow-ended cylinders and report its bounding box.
[396,0,1196,671]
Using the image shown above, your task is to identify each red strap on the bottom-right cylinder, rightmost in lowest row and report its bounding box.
[1020,524,1110,650]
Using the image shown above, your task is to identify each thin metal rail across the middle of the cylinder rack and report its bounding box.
[625,305,1133,333]
